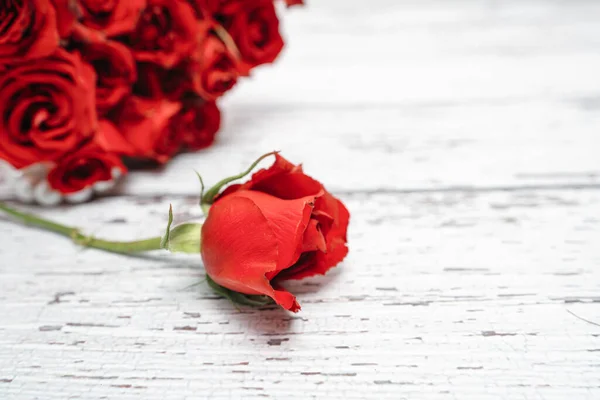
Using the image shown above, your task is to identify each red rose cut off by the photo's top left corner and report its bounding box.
[0,0,59,64]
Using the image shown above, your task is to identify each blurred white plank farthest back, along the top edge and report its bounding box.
[239,0,600,107]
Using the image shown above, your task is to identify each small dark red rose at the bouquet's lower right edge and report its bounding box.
[171,101,221,150]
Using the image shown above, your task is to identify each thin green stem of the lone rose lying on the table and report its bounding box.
[0,202,161,254]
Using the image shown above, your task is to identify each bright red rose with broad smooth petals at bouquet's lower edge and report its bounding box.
[117,96,182,163]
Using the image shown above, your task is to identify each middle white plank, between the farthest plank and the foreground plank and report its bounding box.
[121,102,600,194]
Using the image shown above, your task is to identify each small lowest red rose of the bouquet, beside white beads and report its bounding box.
[48,145,127,194]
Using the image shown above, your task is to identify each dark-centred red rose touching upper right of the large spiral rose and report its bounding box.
[78,30,137,115]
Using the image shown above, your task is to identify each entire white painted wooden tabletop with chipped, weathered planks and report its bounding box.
[0,0,600,400]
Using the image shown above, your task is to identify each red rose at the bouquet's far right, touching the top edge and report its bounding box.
[223,0,283,73]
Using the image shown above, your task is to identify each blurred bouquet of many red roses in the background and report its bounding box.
[0,0,302,198]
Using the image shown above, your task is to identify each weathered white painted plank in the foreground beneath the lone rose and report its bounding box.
[0,190,600,400]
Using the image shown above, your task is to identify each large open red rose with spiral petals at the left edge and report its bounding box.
[0,49,98,168]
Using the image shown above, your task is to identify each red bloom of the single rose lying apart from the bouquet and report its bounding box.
[202,156,349,311]
